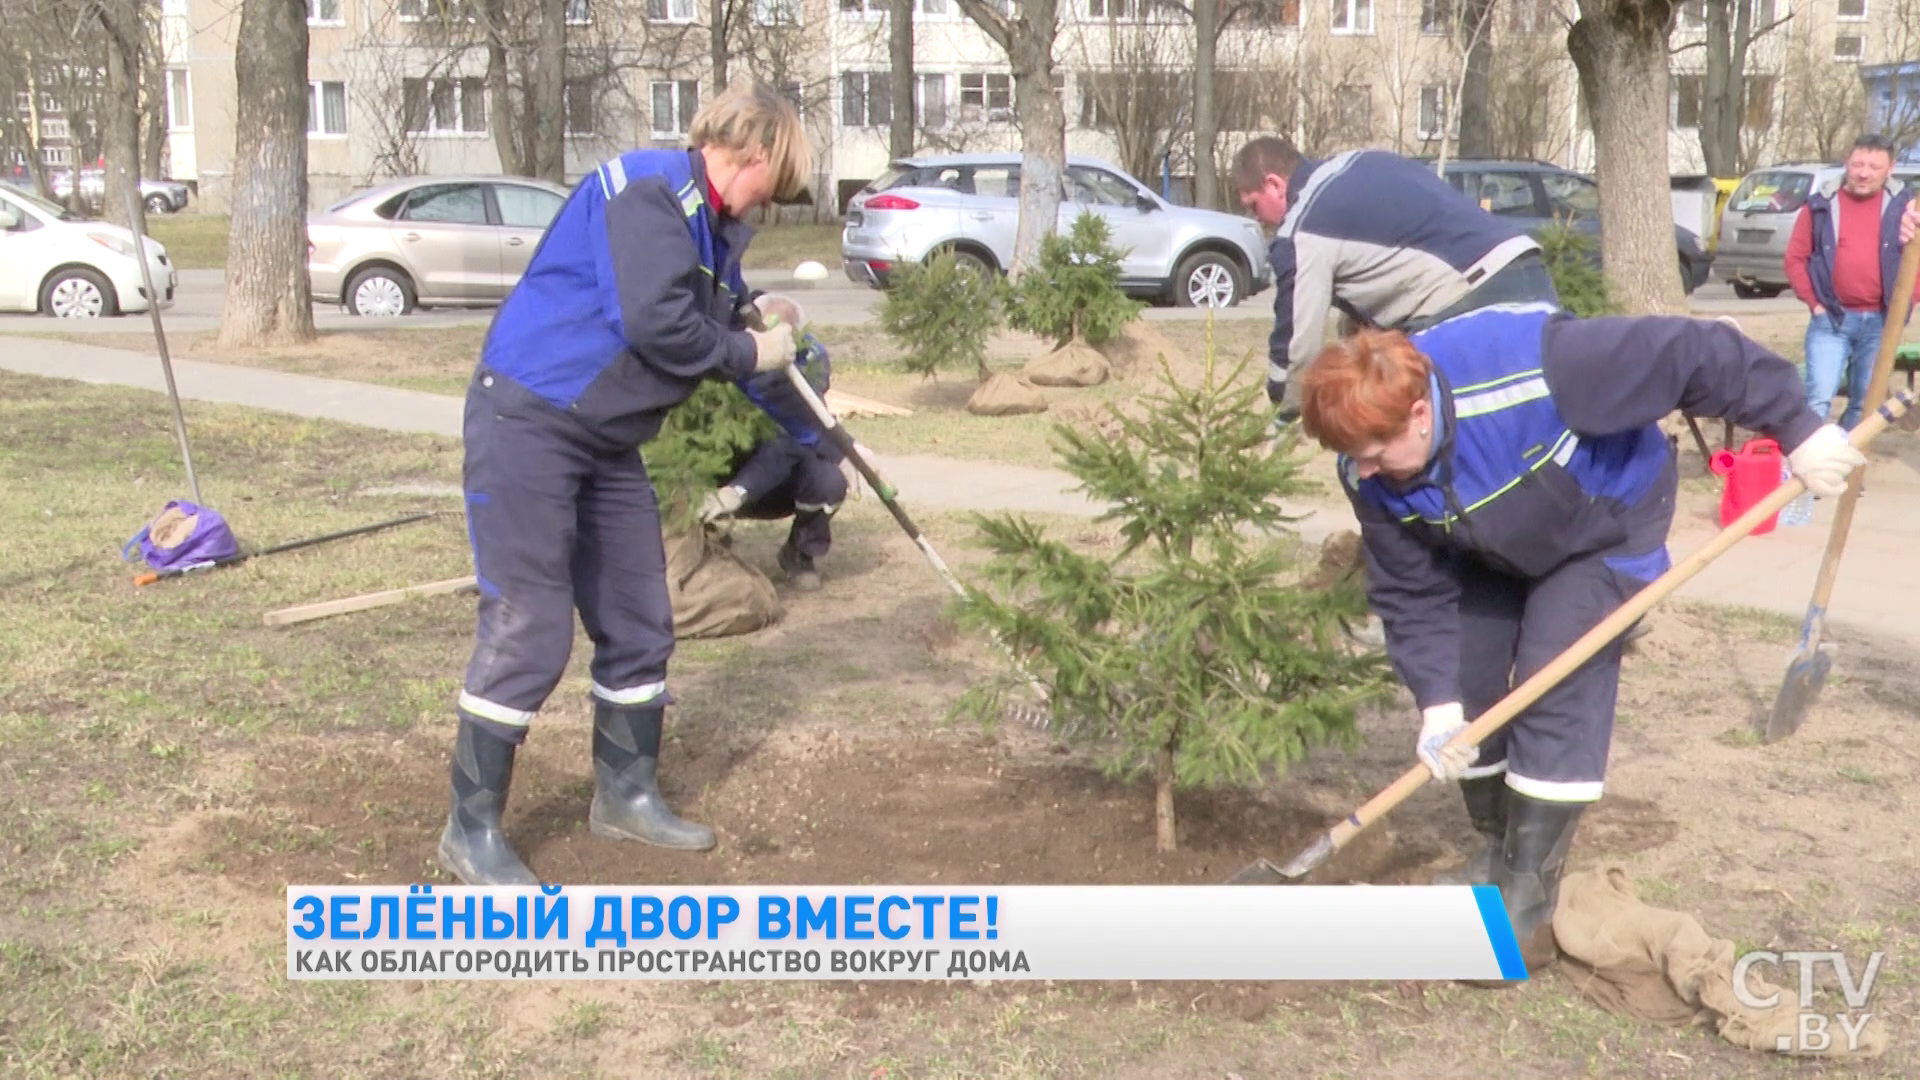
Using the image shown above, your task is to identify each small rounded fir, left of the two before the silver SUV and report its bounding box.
[879,250,1000,382]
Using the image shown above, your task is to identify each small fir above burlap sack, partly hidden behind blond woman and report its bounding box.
[641,380,780,532]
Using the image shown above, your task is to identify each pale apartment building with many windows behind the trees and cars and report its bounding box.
[163,0,1920,209]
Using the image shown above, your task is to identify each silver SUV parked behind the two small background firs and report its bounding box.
[841,154,1273,307]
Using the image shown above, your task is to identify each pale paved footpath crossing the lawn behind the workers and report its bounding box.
[0,338,1920,640]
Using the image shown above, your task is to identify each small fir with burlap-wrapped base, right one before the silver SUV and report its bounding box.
[1006,213,1146,348]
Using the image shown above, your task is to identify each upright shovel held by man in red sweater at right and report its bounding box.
[1755,240,1920,742]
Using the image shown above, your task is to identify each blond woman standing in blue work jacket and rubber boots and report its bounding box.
[440,86,812,886]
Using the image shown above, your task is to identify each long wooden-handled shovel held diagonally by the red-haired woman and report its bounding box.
[1227,384,1920,884]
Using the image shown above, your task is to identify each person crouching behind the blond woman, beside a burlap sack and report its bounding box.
[701,294,860,592]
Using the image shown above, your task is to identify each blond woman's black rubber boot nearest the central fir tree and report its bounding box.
[588,700,714,851]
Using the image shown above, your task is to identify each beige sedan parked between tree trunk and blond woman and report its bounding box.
[307,177,566,317]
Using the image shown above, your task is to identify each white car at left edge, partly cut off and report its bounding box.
[0,183,180,319]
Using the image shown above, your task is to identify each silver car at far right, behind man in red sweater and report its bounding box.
[1713,161,1920,300]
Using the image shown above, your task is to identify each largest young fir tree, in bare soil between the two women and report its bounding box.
[958,319,1392,851]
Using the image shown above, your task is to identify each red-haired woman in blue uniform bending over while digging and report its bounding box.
[1300,304,1864,970]
